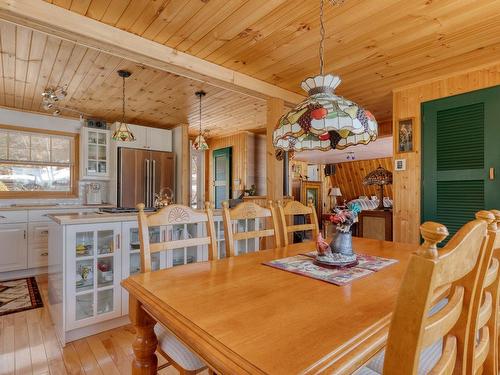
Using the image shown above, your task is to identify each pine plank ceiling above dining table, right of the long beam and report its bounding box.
[42,0,500,127]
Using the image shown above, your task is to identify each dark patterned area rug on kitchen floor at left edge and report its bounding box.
[0,277,43,316]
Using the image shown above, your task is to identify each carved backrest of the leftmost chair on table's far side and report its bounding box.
[137,203,217,272]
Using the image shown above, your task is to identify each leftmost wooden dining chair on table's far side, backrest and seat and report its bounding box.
[137,203,217,375]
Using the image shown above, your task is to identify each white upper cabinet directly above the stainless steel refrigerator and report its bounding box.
[111,123,172,152]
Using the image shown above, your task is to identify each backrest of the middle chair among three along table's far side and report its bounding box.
[222,201,281,257]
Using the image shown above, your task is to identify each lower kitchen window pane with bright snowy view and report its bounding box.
[0,163,71,192]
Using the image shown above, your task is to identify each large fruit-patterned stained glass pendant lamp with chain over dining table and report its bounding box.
[273,0,378,151]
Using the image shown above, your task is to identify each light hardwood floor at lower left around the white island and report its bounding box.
[0,276,208,375]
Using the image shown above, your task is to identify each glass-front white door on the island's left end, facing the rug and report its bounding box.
[66,223,121,329]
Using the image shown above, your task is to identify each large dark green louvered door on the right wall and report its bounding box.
[422,86,500,242]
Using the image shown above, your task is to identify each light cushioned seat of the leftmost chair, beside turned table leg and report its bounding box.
[154,324,206,371]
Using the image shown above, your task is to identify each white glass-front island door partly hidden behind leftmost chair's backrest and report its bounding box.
[121,221,167,315]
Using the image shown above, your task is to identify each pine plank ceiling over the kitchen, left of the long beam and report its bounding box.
[0,21,265,136]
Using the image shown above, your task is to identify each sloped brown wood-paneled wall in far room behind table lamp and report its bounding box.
[330,158,394,203]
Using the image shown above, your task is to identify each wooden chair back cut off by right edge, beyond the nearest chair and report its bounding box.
[476,210,500,375]
